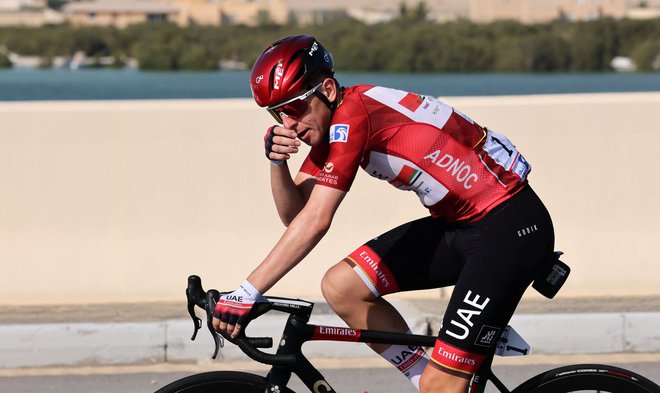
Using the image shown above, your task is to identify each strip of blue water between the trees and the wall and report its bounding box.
[0,69,660,101]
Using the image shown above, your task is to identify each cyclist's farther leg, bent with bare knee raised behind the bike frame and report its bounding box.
[321,217,460,352]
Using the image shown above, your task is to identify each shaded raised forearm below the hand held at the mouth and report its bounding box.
[270,161,306,226]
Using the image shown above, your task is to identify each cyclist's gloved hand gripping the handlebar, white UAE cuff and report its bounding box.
[213,280,268,338]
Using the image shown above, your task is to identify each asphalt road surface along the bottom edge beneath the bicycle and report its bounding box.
[0,356,660,393]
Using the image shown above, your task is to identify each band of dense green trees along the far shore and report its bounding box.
[0,15,660,72]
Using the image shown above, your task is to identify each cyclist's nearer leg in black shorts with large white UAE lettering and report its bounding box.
[421,188,554,392]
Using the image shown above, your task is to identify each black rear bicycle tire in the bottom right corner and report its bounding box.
[512,364,660,393]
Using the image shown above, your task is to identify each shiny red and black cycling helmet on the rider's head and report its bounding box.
[250,35,334,107]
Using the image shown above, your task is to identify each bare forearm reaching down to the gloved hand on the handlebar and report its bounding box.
[247,204,332,293]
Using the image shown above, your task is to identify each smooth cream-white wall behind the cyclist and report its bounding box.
[0,93,660,304]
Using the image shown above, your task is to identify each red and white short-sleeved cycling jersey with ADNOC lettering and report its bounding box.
[300,85,531,222]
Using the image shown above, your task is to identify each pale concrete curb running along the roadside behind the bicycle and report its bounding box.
[0,304,660,368]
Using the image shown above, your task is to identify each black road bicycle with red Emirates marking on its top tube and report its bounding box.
[156,276,660,393]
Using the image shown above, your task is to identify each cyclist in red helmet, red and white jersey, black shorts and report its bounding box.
[213,35,554,392]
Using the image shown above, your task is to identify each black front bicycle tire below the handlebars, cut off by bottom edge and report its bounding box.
[156,371,295,393]
